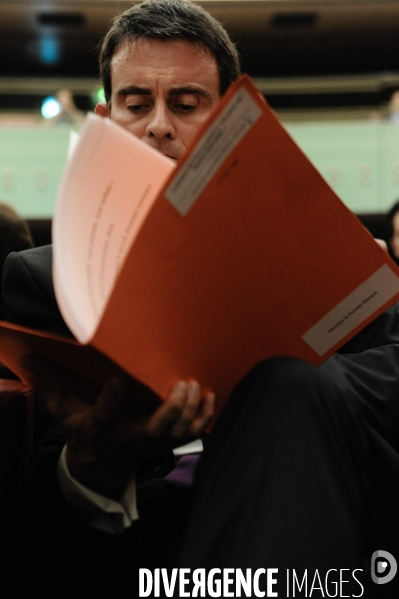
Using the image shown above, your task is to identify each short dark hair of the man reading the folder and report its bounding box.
[99,0,240,103]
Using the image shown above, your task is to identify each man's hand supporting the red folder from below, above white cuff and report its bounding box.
[23,356,215,497]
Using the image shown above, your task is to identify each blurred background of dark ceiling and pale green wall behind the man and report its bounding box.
[0,0,399,246]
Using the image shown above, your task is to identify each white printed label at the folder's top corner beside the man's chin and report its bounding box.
[165,88,262,216]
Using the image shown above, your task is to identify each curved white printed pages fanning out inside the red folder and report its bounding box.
[53,113,176,343]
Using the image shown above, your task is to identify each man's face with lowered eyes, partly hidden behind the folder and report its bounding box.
[95,39,220,160]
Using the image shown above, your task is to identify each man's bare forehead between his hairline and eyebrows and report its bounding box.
[111,39,219,93]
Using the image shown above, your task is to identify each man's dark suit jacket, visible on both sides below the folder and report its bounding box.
[3,246,399,598]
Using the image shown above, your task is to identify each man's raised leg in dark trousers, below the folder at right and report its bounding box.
[181,358,399,597]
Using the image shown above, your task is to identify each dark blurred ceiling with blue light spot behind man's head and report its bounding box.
[0,0,399,111]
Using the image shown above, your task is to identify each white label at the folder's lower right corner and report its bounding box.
[302,264,399,356]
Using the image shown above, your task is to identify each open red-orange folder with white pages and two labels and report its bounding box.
[0,75,399,418]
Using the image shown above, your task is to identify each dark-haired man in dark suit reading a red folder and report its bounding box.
[3,0,399,597]
